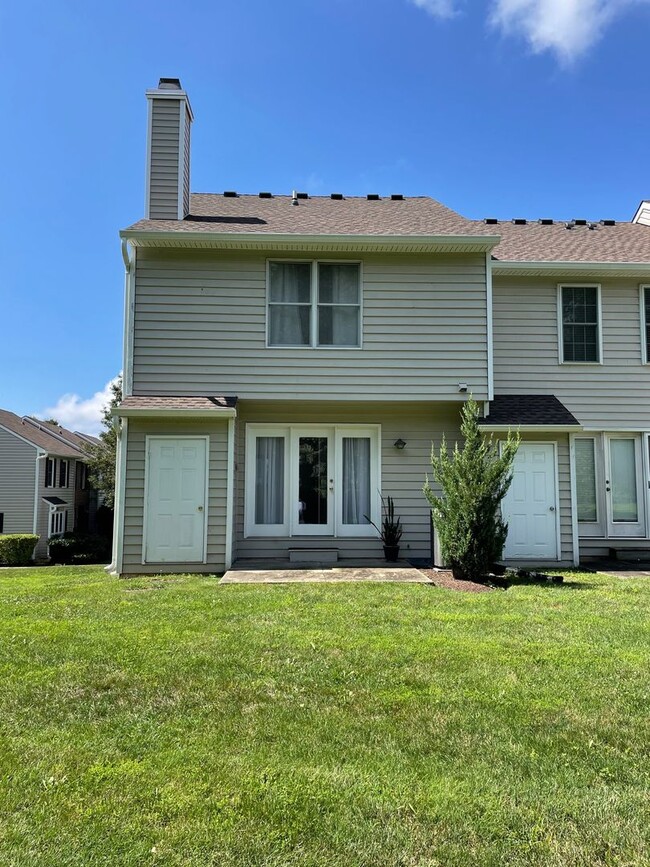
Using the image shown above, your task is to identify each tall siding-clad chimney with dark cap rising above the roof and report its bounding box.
[144,78,194,220]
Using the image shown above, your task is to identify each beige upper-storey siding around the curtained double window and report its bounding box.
[133,248,487,401]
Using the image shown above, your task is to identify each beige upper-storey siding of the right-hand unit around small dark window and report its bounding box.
[494,277,650,430]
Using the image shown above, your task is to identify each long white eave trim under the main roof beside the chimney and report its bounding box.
[120,229,498,253]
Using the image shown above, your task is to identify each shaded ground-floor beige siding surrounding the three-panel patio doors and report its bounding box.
[235,401,460,559]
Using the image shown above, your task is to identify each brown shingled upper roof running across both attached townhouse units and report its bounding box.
[124,193,650,263]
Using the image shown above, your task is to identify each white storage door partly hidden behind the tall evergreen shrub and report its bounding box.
[501,443,558,560]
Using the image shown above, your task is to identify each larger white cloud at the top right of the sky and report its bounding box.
[490,0,647,64]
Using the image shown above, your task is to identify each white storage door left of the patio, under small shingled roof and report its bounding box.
[144,437,208,563]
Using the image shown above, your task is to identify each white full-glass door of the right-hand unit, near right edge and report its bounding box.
[605,434,645,537]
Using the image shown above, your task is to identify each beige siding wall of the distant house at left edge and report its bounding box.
[0,428,37,533]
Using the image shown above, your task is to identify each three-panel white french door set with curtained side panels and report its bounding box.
[245,424,380,537]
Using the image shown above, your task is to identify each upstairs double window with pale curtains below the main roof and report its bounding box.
[268,262,361,347]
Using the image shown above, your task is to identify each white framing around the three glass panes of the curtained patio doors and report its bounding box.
[244,423,381,539]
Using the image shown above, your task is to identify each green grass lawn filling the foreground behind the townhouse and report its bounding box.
[0,567,650,867]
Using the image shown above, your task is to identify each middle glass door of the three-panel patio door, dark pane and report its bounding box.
[290,428,334,536]
